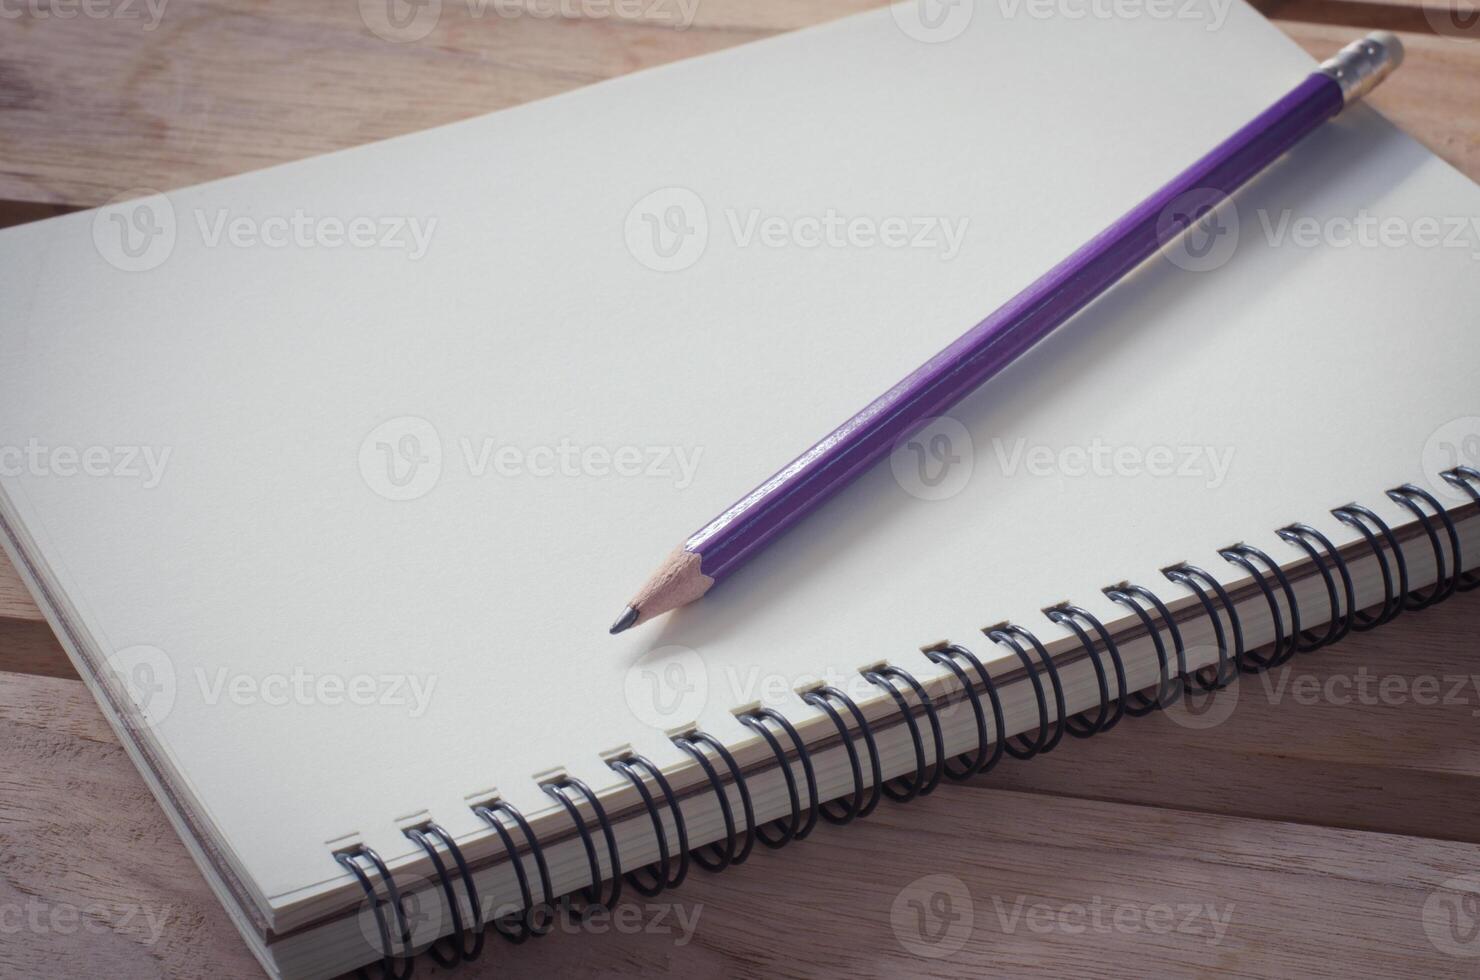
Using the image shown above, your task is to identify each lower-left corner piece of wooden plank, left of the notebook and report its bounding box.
[0,674,260,977]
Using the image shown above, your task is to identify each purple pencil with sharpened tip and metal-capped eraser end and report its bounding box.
[611,31,1403,634]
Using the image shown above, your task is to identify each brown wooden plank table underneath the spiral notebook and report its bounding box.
[0,0,1480,977]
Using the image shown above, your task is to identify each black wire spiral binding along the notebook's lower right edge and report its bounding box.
[333,466,1480,980]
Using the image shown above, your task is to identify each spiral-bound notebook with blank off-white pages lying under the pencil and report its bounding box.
[0,1,1480,977]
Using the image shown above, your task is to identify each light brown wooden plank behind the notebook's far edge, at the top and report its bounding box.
[0,0,1480,206]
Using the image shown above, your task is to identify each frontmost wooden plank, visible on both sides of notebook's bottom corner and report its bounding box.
[0,675,1480,977]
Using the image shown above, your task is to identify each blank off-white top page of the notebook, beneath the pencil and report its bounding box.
[0,3,1480,923]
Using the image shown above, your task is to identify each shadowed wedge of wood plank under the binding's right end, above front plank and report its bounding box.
[987,594,1480,842]
